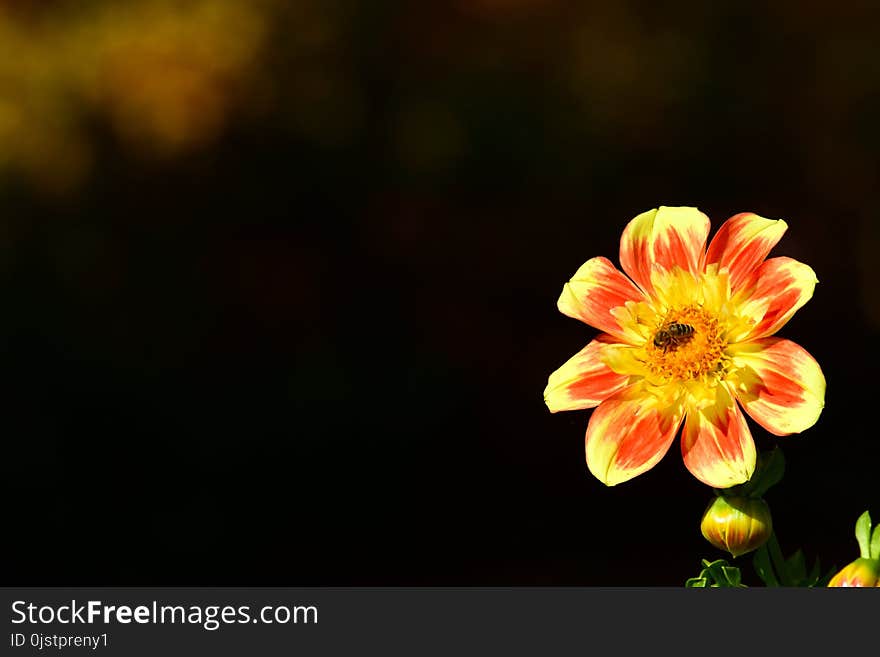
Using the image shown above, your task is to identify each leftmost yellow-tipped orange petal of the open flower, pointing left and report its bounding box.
[544,334,629,413]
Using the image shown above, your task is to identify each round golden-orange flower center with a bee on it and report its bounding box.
[645,306,727,380]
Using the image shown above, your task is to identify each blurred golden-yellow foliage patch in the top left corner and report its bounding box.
[0,0,273,189]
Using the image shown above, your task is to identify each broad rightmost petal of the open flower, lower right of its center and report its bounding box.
[730,338,825,436]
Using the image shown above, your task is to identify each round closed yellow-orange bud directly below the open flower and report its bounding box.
[700,495,773,557]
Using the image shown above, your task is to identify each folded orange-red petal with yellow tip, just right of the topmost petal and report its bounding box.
[705,212,788,292]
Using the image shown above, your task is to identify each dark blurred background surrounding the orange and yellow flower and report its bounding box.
[0,0,880,586]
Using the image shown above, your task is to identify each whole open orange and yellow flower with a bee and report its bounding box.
[544,207,825,488]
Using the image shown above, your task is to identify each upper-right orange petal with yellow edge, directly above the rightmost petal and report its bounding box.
[730,257,819,342]
